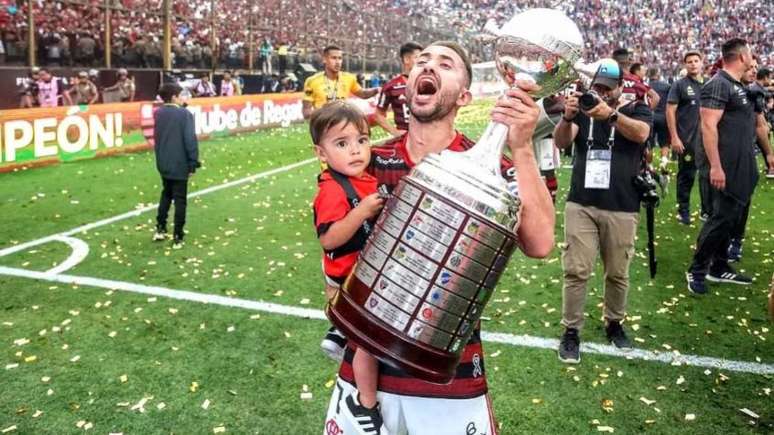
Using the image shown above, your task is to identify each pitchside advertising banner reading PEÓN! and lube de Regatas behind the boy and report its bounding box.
[0,93,304,172]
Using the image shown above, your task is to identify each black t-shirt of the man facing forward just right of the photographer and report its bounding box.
[667,77,703,154]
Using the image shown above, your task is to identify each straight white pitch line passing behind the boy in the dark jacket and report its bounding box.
[0,158,317,257]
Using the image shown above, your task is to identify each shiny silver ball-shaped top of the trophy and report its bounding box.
[495,8,583,99]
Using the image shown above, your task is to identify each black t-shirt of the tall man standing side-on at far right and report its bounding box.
[701,70,758,203]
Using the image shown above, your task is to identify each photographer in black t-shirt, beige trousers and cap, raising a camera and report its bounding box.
[554,59,652,364]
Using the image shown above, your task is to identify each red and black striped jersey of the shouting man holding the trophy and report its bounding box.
[339,132,513,399]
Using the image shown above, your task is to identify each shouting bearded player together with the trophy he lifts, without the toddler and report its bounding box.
[324,9,582,435]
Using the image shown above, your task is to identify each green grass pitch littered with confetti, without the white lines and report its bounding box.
[0,103,774,434]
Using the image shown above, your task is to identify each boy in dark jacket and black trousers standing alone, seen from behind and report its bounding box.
[153,83,201,249]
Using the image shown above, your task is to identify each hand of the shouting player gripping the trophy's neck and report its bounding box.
[492,82,540,154]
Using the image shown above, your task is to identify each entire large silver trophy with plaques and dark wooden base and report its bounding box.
[327,5,582,383]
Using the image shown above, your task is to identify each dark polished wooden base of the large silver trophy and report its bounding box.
[325,276,459,384]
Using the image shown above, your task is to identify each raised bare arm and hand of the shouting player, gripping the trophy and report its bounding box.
[492,86,555,258]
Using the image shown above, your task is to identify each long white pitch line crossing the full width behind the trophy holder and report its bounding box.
[0,266,774,375]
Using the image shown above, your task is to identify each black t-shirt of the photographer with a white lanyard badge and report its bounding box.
[567,101,653,212]
